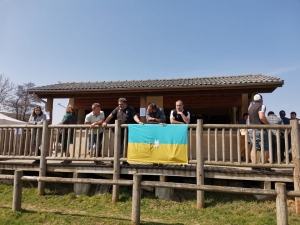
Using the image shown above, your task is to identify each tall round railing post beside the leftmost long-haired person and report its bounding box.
[38,120,49,195]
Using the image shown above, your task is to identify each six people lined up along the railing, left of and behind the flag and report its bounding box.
[28,98,190,165]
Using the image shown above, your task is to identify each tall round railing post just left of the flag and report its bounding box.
[112,120,121,203]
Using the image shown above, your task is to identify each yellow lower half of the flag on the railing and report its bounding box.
[127,143,188,164]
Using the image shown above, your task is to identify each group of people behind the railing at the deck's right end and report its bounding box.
[243,94,300,170]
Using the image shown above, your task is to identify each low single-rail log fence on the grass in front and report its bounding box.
[0,170,300,225]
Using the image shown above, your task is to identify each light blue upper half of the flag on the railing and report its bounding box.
[128,124,188,144]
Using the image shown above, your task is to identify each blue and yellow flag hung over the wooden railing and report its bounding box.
[127,124,188,164]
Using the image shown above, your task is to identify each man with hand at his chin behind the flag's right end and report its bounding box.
[170,100,191,124]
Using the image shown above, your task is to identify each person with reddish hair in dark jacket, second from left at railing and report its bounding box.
[59,106,77,164]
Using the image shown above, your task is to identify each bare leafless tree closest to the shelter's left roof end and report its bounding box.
[7,82,42,121]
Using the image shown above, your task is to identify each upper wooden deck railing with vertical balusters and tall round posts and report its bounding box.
[0,120,300,215]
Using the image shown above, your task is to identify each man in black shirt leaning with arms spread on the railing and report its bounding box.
[102,98,143,166]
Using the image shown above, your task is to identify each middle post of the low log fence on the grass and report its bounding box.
[131,173,142,225]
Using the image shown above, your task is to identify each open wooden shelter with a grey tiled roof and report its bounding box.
[28,74,284,124]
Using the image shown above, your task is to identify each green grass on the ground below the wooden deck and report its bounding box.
[0,184,300,225]
